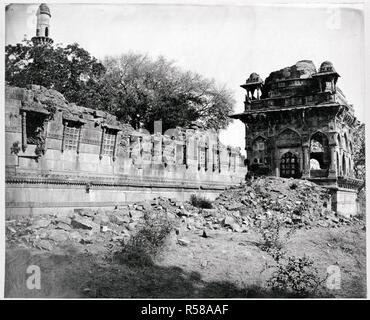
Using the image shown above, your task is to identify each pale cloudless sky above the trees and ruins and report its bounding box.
[5,2,365,151]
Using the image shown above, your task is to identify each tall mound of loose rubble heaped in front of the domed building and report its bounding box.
[214,177,336,226]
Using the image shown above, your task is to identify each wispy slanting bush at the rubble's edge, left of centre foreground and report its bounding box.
[116,214,174,265]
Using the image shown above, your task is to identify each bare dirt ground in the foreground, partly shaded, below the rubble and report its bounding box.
[5,226,366,298]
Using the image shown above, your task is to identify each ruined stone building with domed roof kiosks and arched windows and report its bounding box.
[232,60,362,216]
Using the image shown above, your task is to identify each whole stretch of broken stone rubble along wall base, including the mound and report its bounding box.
[6,177,356,250]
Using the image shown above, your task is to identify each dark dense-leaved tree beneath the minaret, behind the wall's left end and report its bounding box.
[5,41,105,106]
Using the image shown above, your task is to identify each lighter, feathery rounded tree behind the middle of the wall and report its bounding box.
[102,53,234,130]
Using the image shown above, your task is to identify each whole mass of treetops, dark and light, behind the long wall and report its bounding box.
[5,42,235,130]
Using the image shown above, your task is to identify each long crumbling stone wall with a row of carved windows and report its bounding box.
[5,86,247,214]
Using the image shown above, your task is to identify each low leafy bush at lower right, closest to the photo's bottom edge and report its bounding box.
[267,256,325,298]
